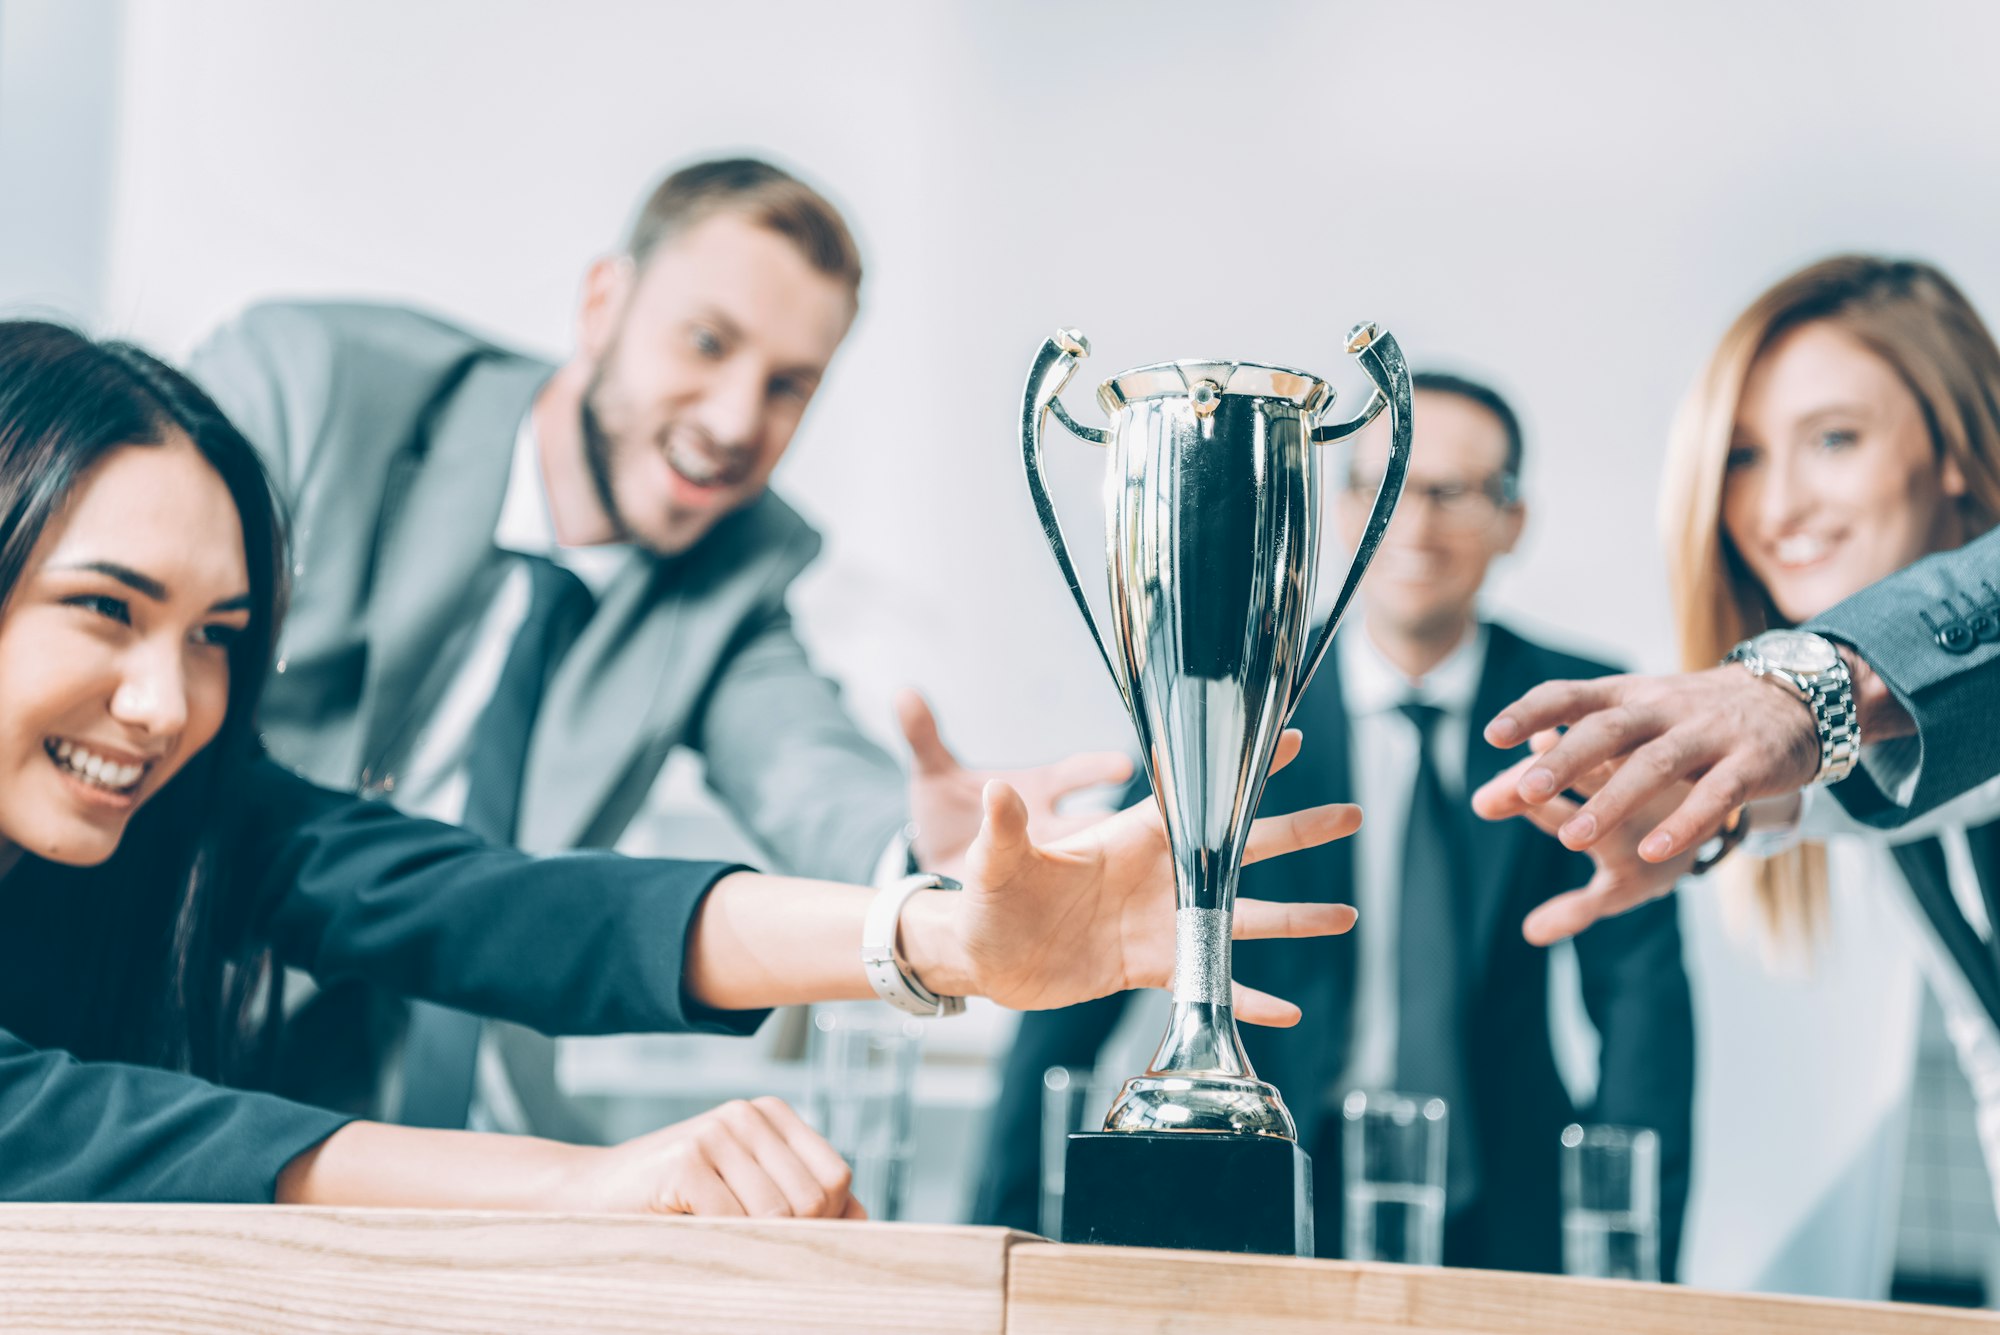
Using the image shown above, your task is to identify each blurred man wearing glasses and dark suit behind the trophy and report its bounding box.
[978,374,1694,1277]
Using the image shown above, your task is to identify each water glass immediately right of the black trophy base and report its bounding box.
[1340,1089,1450,1265]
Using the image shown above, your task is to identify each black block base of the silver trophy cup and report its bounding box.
[1062,1131,1312,1257]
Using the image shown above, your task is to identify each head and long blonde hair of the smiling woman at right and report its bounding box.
[1662,256,2000,935]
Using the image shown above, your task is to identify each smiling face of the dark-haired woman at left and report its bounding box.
[0,430,250,865]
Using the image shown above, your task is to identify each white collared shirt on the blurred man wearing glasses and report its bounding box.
[1326,620,1486,1101]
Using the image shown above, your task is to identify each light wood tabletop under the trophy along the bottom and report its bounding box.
[0,1205,2000,1335]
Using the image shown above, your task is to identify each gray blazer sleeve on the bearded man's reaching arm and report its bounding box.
[696,602,908,885]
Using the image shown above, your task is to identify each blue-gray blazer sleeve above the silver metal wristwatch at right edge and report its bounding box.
[1806,530,2000,827]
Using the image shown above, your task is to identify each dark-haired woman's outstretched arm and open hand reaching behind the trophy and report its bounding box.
[240,733,1360,1033]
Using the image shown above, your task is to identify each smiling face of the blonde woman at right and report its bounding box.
[1722,320,1966,624]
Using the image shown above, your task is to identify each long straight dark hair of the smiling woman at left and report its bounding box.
[0,320,286,1077]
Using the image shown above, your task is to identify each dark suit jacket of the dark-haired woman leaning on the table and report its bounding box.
[0,763,764,1201]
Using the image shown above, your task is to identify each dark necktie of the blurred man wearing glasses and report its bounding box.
[1396,701,1478,1213]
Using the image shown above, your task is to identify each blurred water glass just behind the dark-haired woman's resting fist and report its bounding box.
[806,1003,924,1219]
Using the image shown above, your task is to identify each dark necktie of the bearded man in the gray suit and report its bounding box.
[396,556,592,1129]
